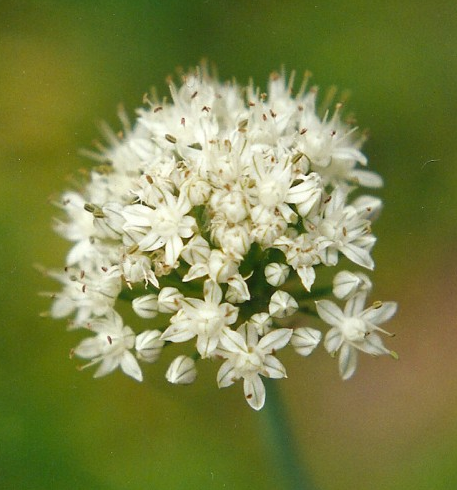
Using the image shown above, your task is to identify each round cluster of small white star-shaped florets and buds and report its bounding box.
[47,69,395,410]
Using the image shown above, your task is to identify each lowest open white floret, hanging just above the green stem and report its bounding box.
[217,325,292,410]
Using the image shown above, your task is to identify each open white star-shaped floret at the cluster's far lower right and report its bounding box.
[316,293,397,379]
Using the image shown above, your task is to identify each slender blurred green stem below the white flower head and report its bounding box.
[261,378,316,490]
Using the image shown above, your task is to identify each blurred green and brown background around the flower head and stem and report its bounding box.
[0,0,457,490]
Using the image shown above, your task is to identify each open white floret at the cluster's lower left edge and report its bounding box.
[74,311,143,381]
